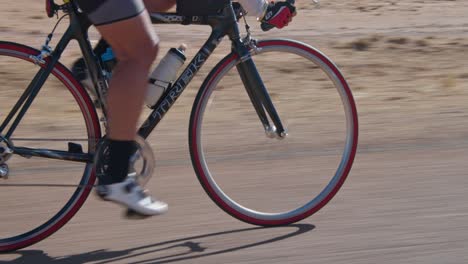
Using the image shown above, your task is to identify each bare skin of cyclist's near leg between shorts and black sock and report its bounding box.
[97,11,158,140]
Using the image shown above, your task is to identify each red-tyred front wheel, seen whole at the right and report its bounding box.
[189,40,358,226]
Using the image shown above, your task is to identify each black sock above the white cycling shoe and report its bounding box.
[99,139,135,185]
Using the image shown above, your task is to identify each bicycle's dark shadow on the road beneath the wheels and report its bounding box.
[0,224,315,264]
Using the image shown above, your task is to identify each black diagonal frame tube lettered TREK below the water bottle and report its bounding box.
[138,31,224,138]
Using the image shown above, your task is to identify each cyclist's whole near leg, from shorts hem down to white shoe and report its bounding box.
[79,0,167,215]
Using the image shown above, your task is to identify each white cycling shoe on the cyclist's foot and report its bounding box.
[96,175,169,217]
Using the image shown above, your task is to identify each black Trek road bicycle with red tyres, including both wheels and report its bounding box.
[0,0,358,252]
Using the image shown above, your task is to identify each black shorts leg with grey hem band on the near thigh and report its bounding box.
[77,0,145,26]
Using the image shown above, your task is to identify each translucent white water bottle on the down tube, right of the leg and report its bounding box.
[145,44,187,108]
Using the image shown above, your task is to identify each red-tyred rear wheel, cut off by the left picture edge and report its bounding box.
[0,42,101,252]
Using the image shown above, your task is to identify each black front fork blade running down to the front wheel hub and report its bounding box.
[236,41,288,139]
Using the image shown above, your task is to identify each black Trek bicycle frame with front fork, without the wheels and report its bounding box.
[0,2,285,162]
